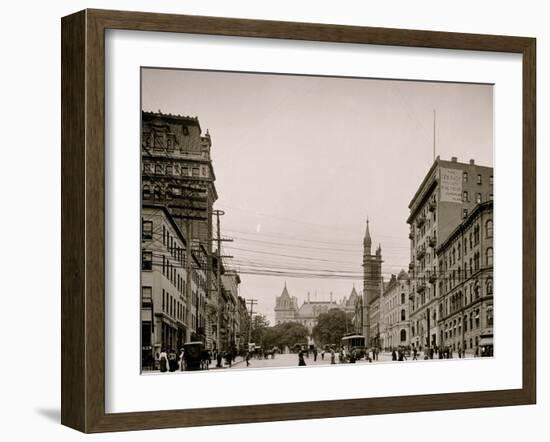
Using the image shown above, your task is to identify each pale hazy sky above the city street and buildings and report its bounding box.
[142,68,494,323]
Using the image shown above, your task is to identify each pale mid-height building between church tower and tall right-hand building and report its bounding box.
[380,270,410,350]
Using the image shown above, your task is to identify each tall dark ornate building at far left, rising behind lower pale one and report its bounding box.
[141,111,218,346]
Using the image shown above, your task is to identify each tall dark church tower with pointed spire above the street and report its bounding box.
[362,218,383,345]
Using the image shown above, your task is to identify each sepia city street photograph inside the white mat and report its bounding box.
[139,67,495,374]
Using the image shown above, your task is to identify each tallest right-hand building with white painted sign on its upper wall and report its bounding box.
[407,157,493,348]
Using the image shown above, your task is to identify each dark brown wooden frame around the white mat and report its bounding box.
[61,10,536,432]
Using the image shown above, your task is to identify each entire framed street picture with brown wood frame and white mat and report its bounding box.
[61,10,536,432]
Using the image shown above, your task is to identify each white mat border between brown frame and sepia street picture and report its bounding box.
[105,30,522,413]
